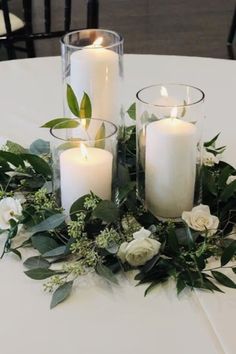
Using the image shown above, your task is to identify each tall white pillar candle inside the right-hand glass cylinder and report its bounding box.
[145,118,197,218]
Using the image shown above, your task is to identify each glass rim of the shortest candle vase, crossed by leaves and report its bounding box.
[49,118,118,143]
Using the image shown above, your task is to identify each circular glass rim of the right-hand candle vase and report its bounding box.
[136,82,205,108]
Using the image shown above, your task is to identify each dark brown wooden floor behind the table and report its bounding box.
[0,0,235,60]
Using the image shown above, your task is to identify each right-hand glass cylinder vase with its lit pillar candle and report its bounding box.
[136,84,205,221]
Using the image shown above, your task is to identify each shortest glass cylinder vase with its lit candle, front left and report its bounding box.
[50,118,117,215]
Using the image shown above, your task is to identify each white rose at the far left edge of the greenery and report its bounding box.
[0,197,22,230]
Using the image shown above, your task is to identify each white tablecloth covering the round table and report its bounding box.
[0,55,236,354]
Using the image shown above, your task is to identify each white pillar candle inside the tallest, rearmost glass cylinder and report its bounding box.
[70,40,120,125]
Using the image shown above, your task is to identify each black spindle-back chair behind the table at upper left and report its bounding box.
[0,0,99,59]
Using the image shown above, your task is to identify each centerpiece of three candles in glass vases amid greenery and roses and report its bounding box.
[0,30,236,308]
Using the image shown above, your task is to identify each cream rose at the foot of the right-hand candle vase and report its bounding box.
[182,204,219,236]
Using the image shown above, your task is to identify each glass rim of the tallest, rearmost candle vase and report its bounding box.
[60,28,124,50]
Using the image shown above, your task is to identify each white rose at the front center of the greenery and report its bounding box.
[117,228,161,267]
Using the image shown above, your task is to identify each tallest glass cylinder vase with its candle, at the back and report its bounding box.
[61,29,124,126]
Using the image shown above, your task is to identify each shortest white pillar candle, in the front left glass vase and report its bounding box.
[60,147,113,213]
